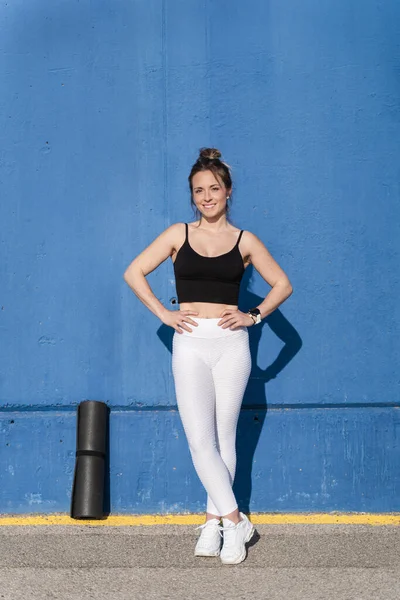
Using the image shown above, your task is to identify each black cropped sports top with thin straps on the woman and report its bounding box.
[174,223,245,306]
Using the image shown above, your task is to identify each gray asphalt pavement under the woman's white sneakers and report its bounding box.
[0,525,400,600]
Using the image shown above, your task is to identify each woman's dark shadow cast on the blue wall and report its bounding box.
[157,265,302,513]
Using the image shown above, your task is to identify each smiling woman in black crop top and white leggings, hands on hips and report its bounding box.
[124,148,292,564]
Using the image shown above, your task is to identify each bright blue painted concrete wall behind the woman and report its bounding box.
[0,0,400,513]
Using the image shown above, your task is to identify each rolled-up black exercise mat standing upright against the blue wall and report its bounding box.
[71,400,108,519]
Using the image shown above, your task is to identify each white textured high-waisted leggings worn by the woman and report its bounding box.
[172,317,251,516]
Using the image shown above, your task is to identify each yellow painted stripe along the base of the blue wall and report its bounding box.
[0,513,400,527]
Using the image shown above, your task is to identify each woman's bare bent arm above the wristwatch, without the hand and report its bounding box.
[243,231,293,319]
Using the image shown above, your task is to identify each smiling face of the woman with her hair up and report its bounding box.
[192,171,229,217]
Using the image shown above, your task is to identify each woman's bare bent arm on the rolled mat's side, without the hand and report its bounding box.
[124,223,182,320]
